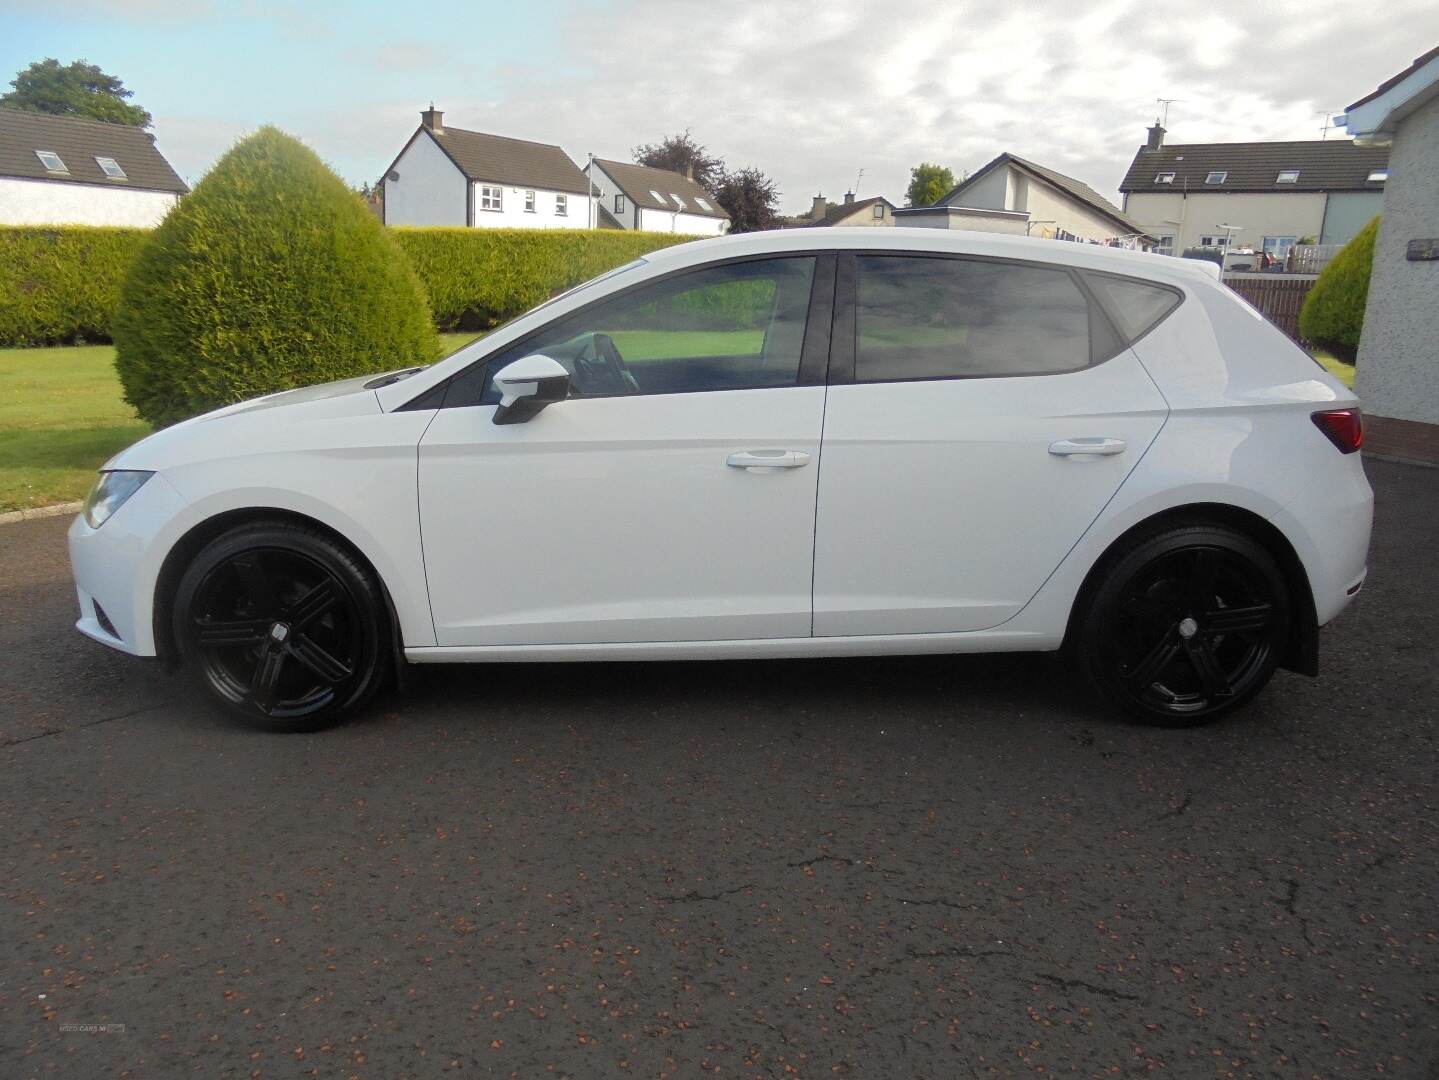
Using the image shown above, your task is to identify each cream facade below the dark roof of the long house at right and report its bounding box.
[1124,191,1325,255]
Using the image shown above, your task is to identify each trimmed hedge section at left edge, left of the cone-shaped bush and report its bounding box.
[0,226,150,345]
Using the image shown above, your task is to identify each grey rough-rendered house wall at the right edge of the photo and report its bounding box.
[1357,94,1439,424]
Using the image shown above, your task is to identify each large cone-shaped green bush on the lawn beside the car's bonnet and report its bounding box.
[114,128,439,426]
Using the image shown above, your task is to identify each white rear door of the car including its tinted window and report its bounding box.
[814,253,1177,636]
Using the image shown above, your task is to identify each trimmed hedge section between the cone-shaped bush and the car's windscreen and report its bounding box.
[391,227,695,331]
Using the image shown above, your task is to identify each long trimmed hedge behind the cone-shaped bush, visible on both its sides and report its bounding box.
[0,224,695,347]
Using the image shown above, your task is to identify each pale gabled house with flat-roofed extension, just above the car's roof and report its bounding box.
[895,154,1154,250]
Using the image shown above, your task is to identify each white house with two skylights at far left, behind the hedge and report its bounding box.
[0,109,190,229]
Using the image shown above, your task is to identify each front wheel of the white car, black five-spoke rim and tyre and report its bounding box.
[173,522,390,732]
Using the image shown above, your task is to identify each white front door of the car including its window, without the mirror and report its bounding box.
[419,257,833,646]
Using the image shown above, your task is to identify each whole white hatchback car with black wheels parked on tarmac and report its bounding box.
[71,229,1373,729]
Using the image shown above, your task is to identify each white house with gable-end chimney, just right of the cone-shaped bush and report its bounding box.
[384,105,594,229]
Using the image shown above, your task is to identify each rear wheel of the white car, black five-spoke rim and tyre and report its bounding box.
[1072,522,1292,728]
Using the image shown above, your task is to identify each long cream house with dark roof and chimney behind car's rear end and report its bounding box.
[1120,122,1389,259]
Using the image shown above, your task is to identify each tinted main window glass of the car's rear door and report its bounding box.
[855,255,1091,383]
